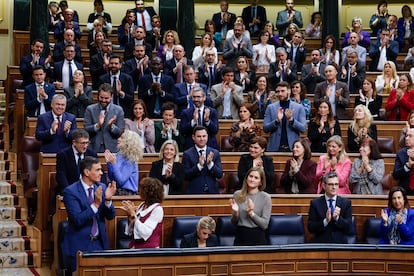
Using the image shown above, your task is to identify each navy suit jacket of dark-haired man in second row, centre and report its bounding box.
[182,146,223,194]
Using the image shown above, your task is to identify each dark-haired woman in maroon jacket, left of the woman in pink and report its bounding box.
[280,138,316,194]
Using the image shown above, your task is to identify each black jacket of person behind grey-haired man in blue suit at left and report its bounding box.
[63,85,93,118]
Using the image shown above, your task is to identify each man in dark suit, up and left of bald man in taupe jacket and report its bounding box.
[301,50,326,94]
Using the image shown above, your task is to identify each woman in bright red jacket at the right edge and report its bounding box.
[385,73,414,121]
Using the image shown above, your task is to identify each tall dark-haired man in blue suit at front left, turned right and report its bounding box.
[62,156,116,275]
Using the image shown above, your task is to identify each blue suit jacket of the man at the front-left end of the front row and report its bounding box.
[62,180,115,271]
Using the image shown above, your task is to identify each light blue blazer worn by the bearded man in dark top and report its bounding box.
[263,101,306,151]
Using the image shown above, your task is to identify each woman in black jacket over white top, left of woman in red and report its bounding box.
[355,79,382,120]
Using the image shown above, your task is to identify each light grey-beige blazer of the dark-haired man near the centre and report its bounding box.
[210,83,243,119]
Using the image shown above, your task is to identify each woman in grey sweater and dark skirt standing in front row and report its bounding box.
[229,167,272,246]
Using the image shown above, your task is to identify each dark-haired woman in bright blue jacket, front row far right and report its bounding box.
[379,186,414,244]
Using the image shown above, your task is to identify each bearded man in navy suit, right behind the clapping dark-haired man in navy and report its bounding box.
[180,87,219,150]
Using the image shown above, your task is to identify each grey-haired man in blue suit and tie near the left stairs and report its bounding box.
[35,94,76,153]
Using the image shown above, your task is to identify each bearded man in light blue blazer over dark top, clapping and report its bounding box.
[263,81,306,152]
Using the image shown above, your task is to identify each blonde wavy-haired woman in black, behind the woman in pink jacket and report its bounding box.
[348,104,377,152]
